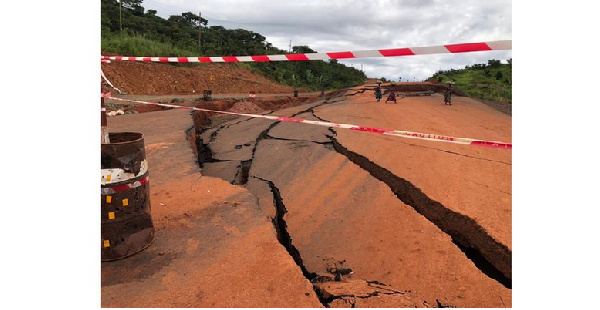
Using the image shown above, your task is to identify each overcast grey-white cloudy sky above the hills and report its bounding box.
[142,0,512,81]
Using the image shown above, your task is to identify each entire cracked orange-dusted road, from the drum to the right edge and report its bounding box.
[102,85,512,307]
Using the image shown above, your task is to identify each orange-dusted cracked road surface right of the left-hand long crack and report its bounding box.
[199,87,512,307]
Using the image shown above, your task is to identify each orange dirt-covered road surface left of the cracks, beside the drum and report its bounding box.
[101,110,321,308]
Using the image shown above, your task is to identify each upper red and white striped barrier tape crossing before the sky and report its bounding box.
[102,40,512,62]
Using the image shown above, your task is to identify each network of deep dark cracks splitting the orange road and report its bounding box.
[190,92,512,307]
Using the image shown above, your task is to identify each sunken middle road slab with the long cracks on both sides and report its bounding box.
[191,91,511,307]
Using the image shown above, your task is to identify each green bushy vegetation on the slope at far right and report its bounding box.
[428,58,512,103]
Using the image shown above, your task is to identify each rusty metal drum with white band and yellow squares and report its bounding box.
[101,132,154,261]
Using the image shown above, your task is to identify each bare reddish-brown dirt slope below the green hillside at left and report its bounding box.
[101,52,303,96]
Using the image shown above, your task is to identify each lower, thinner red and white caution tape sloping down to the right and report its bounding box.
[101,93,512,149]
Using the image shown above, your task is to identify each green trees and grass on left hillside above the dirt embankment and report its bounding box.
[101,0,366,90]
